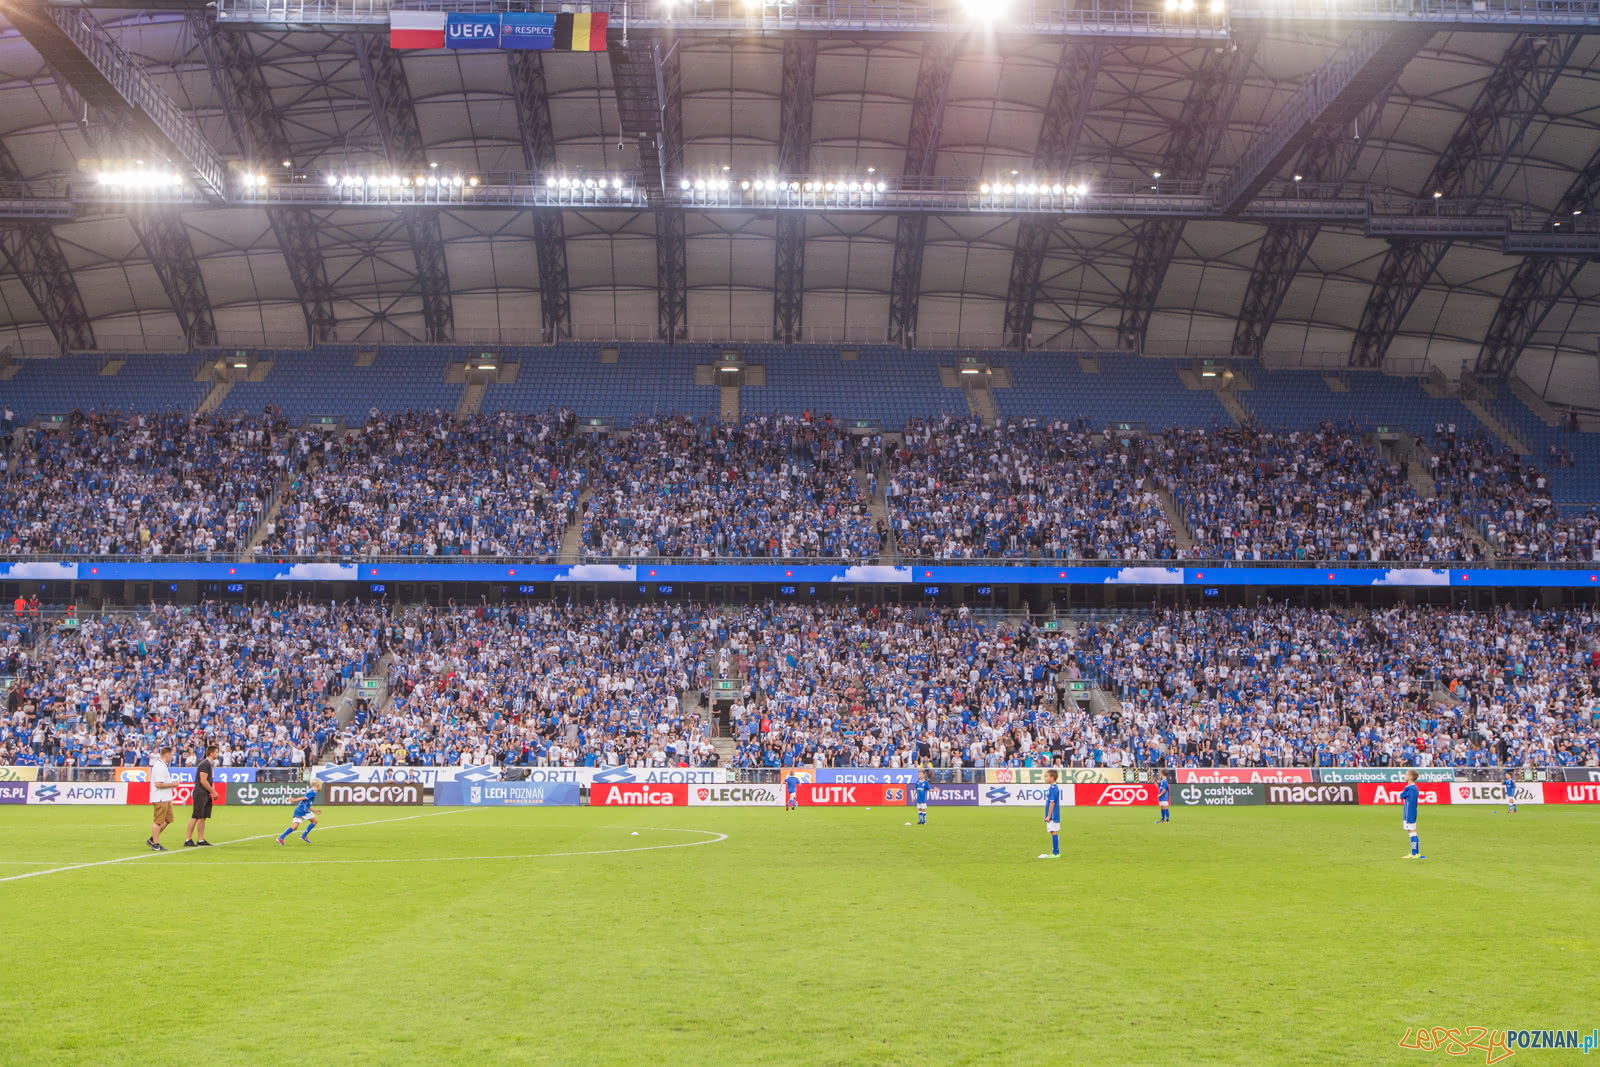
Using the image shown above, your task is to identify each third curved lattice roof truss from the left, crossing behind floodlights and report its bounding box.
[189,11,338,344]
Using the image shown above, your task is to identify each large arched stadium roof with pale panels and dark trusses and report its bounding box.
[0,0,1600,396]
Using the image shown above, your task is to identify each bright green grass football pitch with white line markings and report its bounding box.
[0,806,1600,1064]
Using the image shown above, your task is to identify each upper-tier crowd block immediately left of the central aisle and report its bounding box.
[582,416,883,560]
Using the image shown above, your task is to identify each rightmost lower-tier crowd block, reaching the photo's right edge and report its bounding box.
[1075,605,1600,766]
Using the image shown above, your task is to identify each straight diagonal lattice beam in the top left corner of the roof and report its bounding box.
[6,2,227,200]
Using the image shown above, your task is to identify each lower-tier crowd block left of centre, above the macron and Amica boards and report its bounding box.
[333,603,714,766]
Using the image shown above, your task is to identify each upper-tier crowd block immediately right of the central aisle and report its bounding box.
[886,418,1176,560]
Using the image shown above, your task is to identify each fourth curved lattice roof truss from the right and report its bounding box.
[1117,38,1256,350]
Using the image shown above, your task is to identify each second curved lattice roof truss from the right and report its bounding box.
[1350,34,1579,366]
